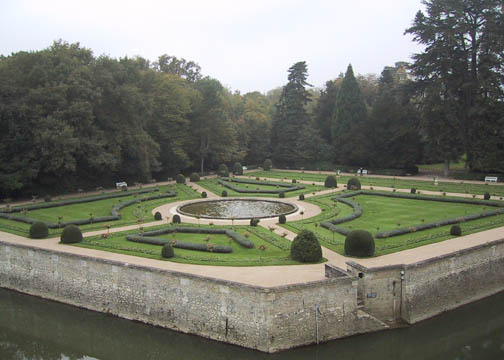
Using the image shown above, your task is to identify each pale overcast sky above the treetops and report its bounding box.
[0,0,422,93]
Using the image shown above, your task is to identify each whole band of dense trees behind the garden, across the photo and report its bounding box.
[0,0,504,196]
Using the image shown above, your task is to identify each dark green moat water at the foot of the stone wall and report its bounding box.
[0,289,504,360]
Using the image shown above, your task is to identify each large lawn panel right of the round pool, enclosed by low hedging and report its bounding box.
[283,191,504,256]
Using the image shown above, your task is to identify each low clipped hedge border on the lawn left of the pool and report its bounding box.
[0,188,177,229]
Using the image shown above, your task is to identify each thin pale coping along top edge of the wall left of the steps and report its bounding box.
[0,240,353,293]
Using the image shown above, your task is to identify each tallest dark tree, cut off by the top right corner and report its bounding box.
[406,0,504,173]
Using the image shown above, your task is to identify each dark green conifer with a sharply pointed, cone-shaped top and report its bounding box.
[332,65,368,165]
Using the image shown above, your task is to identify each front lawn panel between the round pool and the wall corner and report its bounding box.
[75,224,310,266]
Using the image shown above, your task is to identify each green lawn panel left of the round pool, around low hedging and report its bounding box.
[0,184,201,237]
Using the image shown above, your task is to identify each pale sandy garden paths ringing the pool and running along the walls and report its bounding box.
[0,179,504,287]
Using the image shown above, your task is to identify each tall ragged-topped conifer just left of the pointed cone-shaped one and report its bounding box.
[271,61,311,166]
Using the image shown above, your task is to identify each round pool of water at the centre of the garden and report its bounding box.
[177,199,297,220]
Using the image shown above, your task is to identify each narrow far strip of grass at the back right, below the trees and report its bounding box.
[247,171,504,197]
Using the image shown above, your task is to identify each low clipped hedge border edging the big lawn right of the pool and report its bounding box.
[320,190,504,239]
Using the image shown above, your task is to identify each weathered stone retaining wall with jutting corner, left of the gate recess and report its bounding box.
[0,241,384,352]
